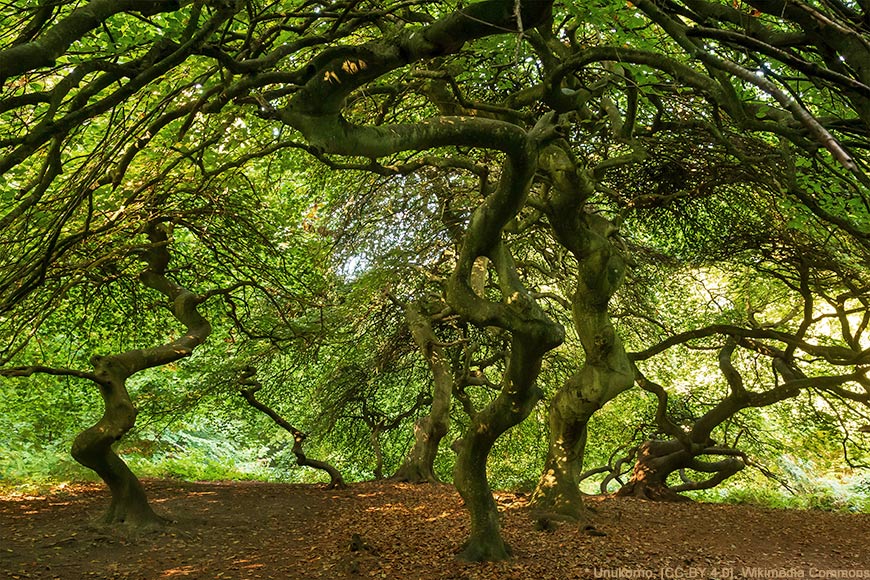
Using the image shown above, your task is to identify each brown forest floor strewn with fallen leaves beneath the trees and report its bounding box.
[0,480,870,580]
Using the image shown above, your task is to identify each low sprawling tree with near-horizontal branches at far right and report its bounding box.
[618,232,870,500]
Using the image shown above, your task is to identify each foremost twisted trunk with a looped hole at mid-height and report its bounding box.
[447,117,565,561]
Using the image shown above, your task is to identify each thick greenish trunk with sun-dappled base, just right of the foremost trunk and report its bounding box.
[531,146,634,520]
